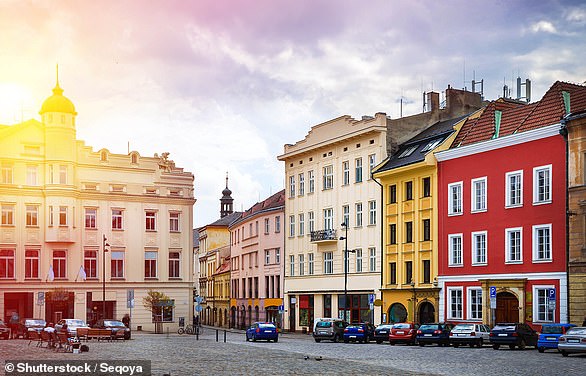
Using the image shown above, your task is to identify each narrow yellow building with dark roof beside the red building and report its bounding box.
[374,113,480,323]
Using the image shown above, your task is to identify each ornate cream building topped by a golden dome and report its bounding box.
[0,78,195,330]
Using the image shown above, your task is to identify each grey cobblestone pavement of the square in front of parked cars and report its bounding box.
[0,328,586,376]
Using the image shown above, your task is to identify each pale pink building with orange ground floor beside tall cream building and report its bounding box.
[230,190,285,328]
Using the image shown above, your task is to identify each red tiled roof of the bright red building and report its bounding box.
[451,81,586,148]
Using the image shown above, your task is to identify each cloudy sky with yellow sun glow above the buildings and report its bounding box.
[0,0,586,227]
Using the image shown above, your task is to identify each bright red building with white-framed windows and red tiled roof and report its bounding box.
[436,82,586,325]
